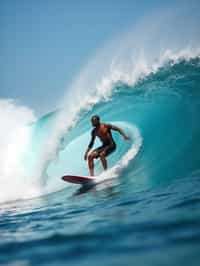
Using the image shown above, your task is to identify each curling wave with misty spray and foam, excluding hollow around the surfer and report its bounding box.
[0,2,200,204]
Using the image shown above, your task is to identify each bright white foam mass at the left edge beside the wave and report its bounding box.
[0,99,38,202]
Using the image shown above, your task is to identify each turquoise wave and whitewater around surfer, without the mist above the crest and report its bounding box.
[1,57,200,201]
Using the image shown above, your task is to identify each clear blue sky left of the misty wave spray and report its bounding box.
[0,0,176,115]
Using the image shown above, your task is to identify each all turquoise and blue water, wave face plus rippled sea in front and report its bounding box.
[0,57,200,266]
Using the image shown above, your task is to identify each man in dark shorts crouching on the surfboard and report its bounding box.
[84,115,130,176]
